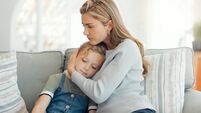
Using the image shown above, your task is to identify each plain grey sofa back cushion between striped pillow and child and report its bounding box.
[17,51,64,112]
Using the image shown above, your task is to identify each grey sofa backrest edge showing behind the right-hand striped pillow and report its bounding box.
[145,47,195,89]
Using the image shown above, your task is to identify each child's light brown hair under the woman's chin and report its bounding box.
[77,42,107,56]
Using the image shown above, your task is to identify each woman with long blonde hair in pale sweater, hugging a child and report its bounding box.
[68,0,155,113]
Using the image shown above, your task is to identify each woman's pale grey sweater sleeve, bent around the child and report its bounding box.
[72,42,142,104]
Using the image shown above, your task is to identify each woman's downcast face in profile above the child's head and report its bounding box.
[82,13,110,45]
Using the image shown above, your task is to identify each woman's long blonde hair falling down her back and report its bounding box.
[80,0,148,74]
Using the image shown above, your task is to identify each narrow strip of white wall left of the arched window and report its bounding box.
[0,0,17,50]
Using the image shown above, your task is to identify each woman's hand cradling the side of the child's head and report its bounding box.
[67,49,78,79]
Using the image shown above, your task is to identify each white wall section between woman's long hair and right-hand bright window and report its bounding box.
[116,0,148,43]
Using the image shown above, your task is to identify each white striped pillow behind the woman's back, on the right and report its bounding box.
[145,49,185,113]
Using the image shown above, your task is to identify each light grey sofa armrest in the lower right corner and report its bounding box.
[183,89,201,113]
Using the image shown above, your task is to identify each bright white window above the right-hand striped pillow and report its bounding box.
[147,0,194,48]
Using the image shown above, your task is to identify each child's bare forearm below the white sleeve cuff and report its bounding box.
[32,95,51,113]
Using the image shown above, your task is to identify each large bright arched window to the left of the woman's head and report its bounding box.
[15,0,87,51]
